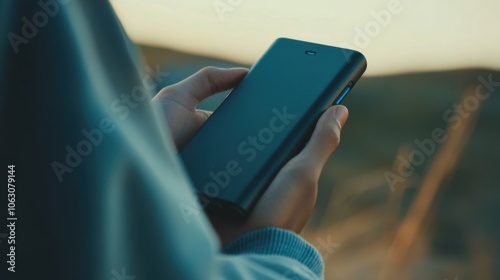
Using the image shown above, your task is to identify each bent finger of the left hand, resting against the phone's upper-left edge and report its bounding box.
[161,67,248,109]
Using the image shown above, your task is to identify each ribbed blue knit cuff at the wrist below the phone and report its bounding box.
[224,227,324,277]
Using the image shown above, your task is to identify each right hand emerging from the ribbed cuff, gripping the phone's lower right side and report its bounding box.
[210,105,349,246]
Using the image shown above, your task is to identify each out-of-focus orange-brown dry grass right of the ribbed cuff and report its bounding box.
[303,89,493,280]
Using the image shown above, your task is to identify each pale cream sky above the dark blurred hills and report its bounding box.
[111,0,500,75]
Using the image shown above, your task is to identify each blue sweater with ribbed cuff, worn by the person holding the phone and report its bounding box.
[0,0,323,280]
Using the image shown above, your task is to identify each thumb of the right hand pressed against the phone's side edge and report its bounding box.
[299,105,349,174]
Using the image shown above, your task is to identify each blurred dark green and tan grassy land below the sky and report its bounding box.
[141,46,500,280]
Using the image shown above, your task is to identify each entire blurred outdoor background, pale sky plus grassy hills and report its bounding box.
[111,0,500,280]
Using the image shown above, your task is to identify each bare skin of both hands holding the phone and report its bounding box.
[152,67,349,246]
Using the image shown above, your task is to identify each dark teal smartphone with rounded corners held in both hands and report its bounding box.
[180,38,366,217]
